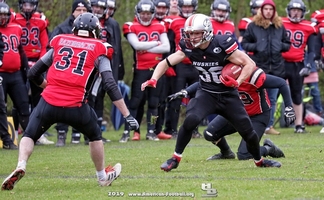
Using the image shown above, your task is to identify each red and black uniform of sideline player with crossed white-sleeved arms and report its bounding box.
[123,19,167,136]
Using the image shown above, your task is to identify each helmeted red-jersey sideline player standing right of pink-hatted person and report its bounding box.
[282,0,317,133]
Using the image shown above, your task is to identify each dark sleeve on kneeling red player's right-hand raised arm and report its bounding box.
[262,74,292,107]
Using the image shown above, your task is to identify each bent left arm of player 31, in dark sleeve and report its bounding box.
[27,49,54,88]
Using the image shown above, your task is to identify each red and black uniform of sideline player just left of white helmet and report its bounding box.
[164,16,199,134]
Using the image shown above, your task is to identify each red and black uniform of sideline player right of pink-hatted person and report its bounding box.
[282,18,317,105]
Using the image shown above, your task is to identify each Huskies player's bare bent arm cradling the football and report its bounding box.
[227,49,256,85]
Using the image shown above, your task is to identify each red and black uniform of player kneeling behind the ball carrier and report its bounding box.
[204,69,292,160]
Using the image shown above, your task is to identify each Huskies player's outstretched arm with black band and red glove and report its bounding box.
[141,50,186,91]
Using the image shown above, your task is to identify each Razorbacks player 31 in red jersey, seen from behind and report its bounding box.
[1,13,138,190]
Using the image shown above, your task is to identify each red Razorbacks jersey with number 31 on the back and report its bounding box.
[42,34,107,107]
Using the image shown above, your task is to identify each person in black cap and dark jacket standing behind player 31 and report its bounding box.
[50,0,90,147]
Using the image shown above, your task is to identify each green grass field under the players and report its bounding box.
[0,126,324,200]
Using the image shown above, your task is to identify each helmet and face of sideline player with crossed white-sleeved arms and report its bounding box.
[135,0,155,26]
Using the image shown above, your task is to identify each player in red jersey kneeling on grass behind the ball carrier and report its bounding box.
[170,68,296,160]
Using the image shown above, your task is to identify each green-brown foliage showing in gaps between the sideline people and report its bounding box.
[7,0,324,123]
